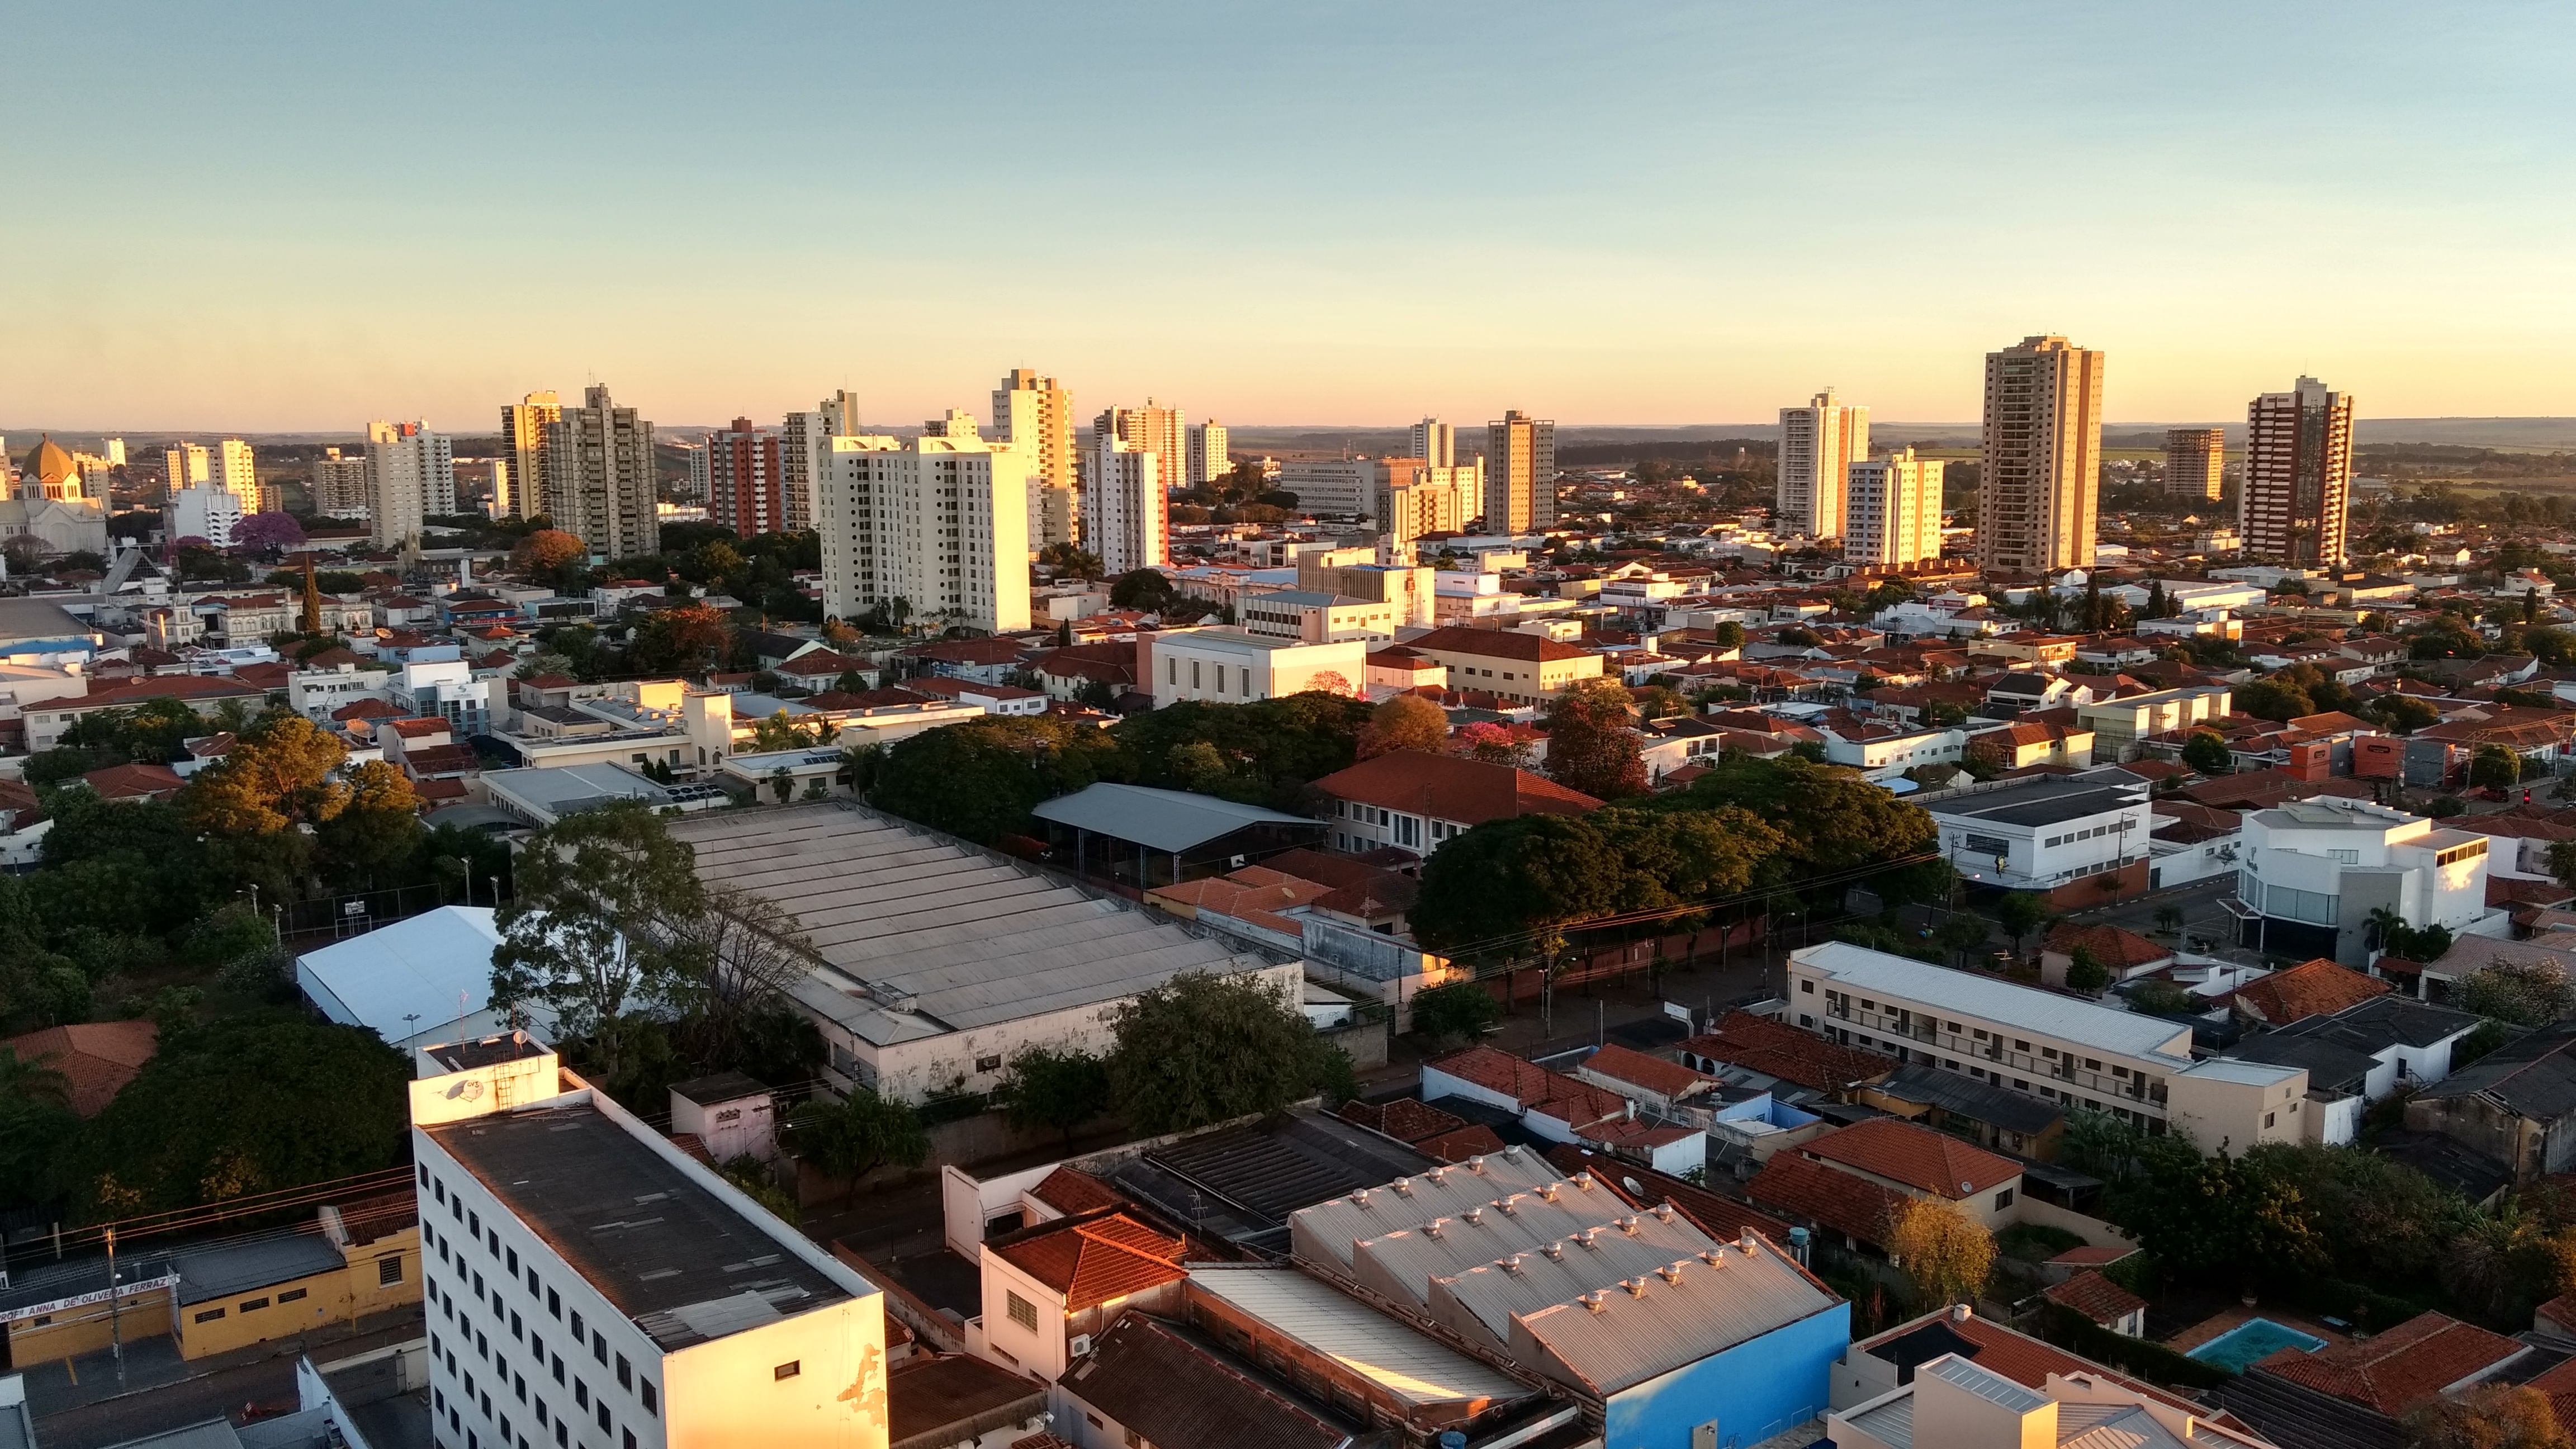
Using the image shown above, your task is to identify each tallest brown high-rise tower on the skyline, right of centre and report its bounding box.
[1976,335,2102,572]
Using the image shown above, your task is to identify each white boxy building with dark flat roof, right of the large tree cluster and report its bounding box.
[1922,768,2156,889]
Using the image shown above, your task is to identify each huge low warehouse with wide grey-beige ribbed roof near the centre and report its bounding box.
[670,802,1304,1101]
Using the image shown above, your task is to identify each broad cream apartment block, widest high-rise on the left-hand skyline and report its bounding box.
[819,408,1028,632]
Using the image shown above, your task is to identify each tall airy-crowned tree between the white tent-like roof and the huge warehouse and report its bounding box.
[492,799,706,1075]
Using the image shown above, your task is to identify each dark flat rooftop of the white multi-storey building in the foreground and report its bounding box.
[425,1104,850,1348]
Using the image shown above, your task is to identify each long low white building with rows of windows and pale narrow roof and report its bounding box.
[1785,941,2308,1153]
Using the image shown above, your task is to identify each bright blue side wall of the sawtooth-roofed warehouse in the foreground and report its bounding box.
[1602,1302,1852,1449]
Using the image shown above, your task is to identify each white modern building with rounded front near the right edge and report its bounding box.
[2225,797,2512,967]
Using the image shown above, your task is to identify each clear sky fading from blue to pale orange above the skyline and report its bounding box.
[0,0,2576,430]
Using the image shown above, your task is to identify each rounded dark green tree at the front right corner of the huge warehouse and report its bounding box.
[1107,972,1350,1137]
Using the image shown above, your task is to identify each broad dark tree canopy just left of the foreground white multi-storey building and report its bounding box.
[67,1016,412,1217]
